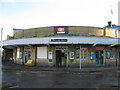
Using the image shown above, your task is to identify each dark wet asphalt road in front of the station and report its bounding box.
[2,61,119,88]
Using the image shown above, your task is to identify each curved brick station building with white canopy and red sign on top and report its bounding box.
[3,22,120,67]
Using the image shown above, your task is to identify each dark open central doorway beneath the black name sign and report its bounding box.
[55,48,67,67]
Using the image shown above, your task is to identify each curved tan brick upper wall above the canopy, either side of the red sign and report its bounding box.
[14,26,118,39]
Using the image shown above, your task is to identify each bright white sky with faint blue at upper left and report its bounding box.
[0,0,119,40]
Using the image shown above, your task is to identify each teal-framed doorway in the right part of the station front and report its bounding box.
[96,50,104,66]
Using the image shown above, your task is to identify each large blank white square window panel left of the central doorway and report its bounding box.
[37,47,47,59]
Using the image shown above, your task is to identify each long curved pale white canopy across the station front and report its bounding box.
[3,36,120,46]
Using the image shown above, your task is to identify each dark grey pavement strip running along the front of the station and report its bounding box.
[2,61,120,72]
